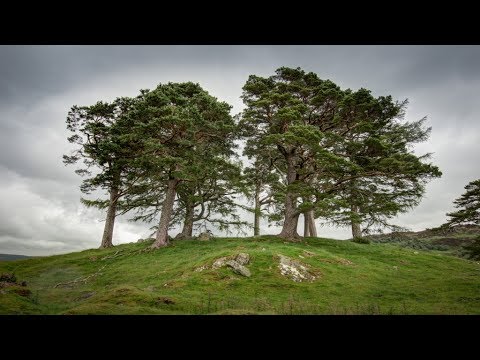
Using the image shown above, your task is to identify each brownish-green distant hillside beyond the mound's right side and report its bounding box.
[366,225,480,258]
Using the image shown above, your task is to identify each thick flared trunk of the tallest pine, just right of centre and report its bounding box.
[278,155,300,241]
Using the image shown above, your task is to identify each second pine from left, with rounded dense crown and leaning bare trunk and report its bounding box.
[129,82,236,248]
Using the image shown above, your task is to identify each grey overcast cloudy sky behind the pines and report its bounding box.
[0,45,480,255]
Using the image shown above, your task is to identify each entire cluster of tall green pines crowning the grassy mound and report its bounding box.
[64,67,441,248]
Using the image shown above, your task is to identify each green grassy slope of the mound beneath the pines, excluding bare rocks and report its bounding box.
[0,236,480,314]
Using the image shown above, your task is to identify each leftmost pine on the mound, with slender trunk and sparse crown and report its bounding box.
[63,97,140,248]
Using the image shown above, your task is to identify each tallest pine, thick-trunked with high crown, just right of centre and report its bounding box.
[241,67,344,240]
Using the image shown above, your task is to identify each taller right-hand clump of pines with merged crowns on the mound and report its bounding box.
[242,67,441,239]
